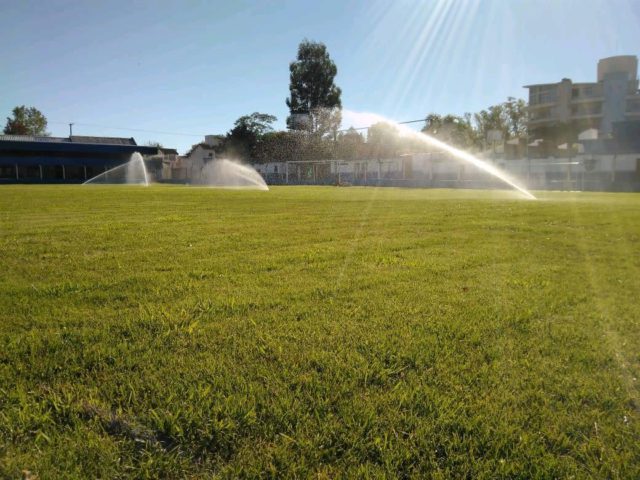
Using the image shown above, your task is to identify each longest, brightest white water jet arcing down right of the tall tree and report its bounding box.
[348,111,536,200]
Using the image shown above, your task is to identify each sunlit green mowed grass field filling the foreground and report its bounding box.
[0,186,640,479]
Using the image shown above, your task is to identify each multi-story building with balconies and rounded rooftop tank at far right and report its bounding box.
[525,55,640,142]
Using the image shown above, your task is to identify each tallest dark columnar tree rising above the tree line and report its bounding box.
[287,40,342,137]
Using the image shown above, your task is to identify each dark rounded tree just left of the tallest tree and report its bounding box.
[224,112,277,160]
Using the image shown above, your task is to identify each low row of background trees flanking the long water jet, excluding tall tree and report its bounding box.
[212,98,527,163]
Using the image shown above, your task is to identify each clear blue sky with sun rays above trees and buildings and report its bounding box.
[0,0,640,152]
